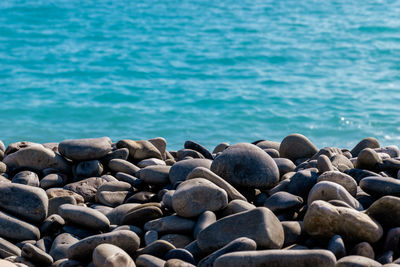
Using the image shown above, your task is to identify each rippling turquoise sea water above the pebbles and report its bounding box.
[0,0,400,149]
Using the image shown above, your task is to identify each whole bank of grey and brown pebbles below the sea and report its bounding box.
[0,134,400,267]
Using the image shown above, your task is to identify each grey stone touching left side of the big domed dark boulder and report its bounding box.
[169,159,212,184]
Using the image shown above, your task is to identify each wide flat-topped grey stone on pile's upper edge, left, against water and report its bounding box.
[58,137,111,161]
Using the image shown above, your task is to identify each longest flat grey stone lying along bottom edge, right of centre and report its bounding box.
[213,249,336,267]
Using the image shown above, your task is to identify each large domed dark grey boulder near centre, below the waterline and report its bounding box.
[211,143,279,189]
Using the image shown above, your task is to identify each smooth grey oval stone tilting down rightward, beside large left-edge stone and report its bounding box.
[58,204,110,231]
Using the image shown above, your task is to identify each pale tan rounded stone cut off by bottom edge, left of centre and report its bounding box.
[93,244,136,267]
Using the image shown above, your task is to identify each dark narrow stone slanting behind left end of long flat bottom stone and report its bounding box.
[197,237,257,267]
